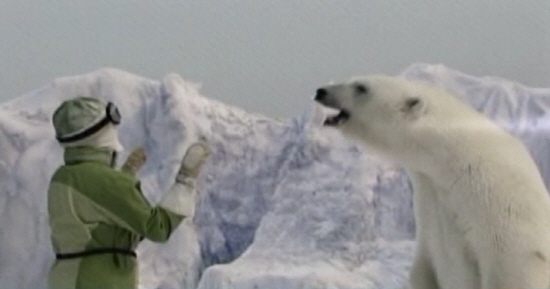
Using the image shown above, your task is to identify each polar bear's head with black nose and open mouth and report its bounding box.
[315,75,454,165]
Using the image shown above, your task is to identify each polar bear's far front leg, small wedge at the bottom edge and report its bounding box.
[409,246,439,289]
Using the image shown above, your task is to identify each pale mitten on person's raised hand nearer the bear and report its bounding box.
[176,141,210,184]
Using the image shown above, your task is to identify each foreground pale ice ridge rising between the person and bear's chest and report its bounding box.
[199,108,414,289]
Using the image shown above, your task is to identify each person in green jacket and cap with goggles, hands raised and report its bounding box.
[48,97,210,289]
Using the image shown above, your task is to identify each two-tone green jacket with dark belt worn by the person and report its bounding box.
[48,147,184,289]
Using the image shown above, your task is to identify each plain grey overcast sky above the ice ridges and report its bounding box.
[0,0,550,117]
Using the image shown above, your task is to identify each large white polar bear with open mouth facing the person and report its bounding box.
[315,75,550,289]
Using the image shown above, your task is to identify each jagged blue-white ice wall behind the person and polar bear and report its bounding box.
[0,64,550,289]
